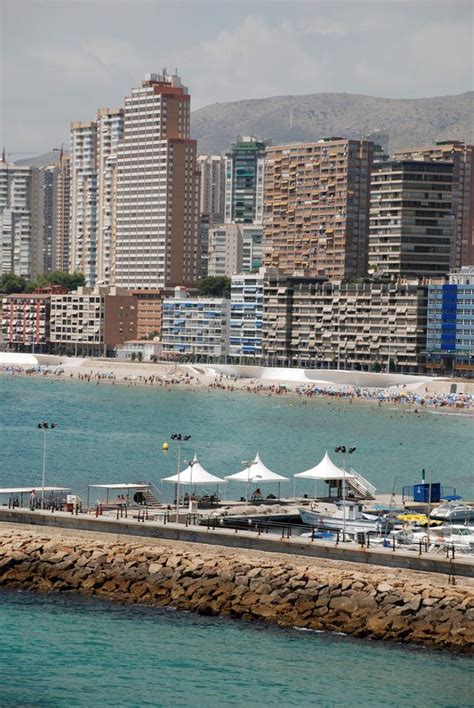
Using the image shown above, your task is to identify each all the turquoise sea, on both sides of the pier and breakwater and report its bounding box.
[0,376,474,708]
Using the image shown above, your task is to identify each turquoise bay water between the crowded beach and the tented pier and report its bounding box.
[0,376,474,501]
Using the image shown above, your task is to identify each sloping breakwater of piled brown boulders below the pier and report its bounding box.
[0,527,474,654]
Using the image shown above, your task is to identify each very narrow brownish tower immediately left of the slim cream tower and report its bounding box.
[53,150,71,271]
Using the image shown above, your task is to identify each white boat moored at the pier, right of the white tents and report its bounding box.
[298,501,388,533]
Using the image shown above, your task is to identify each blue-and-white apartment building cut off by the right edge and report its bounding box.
[426,266,474,377]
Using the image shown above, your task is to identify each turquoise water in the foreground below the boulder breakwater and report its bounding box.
[0,592,472,708]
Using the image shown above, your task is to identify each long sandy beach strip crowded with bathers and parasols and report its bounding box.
[0,361,474,412]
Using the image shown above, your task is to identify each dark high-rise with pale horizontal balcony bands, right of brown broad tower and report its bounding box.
[369,160,454,277]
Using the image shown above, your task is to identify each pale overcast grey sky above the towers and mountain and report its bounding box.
[0,0,473,157]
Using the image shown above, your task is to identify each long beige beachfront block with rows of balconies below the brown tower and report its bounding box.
[263,274,427,373]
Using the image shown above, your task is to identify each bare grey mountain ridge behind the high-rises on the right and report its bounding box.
[191,91,474,154]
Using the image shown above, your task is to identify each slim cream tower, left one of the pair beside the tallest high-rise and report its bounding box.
[69,121,98,286]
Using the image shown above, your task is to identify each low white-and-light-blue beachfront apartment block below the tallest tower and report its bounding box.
[161,288,230,361]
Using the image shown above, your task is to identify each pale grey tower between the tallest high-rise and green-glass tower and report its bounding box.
[197,155,225,226]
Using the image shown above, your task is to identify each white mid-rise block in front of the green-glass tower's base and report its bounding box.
[207,224,243,277]
